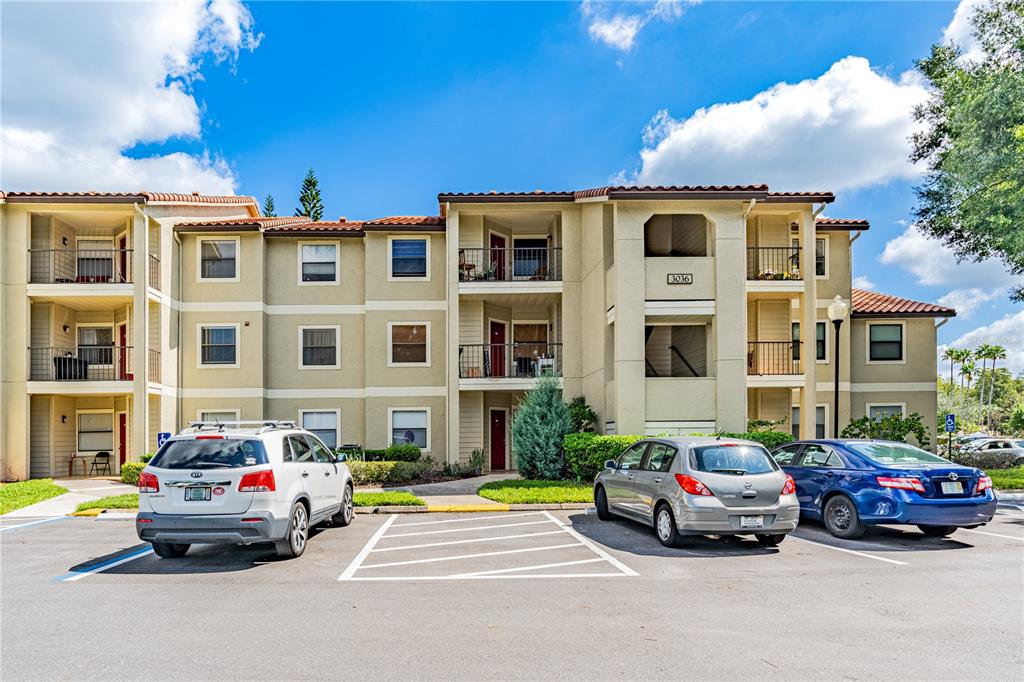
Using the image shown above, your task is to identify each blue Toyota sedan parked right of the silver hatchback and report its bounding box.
[772,439,995,539]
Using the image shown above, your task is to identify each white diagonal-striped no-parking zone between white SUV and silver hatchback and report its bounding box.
[338,511,637,582]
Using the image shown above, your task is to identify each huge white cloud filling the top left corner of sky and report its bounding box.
[0,0,261,191]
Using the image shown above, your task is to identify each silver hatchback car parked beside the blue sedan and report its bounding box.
[594,437,800,547]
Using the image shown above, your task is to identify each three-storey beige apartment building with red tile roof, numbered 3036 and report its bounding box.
[0,185,955,479]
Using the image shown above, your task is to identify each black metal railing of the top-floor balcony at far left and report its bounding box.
[30,249,132,284]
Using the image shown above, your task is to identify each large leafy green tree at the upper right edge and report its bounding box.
[911,0,1024,300]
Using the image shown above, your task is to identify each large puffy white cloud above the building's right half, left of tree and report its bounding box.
[634,56,927,190]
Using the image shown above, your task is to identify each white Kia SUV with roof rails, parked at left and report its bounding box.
[135,421,352,557]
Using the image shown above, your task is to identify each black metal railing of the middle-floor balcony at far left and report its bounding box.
[29,346,133,381]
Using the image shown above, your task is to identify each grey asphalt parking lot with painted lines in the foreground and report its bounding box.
[0,505,1024,680]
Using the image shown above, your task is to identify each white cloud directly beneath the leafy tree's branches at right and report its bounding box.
[879,225,1020,289]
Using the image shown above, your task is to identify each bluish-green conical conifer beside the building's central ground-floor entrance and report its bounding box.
[512,376,572,479]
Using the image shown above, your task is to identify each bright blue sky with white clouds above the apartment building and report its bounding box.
[2,0,1024,369]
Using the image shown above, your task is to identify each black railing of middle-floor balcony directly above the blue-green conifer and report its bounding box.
[459,343,562,379]
